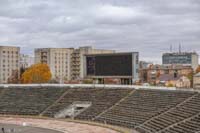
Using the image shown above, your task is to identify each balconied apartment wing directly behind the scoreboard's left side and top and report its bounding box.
[71,46,115,80]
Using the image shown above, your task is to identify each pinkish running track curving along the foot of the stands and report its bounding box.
[0,117,122,133]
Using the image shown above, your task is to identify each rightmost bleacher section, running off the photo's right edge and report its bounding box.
[136,93,200,133]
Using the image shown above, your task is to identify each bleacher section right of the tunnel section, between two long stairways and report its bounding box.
[96,90,194,128]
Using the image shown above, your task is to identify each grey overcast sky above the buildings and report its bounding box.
[0,0,200,62]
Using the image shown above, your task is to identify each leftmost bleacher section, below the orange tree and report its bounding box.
[0,87,68,115]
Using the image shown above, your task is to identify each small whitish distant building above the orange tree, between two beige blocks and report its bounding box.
[20,54,34,69]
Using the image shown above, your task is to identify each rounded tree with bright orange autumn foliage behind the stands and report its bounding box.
[21,64,51,84]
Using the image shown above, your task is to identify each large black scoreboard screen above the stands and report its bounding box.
[86,53,138,76]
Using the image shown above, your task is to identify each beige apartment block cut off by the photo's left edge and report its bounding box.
[0,46,20,83]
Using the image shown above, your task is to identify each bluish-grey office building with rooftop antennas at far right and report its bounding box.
[162,52,199,70]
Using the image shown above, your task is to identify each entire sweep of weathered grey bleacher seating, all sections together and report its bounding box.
[0,87,200,133]
